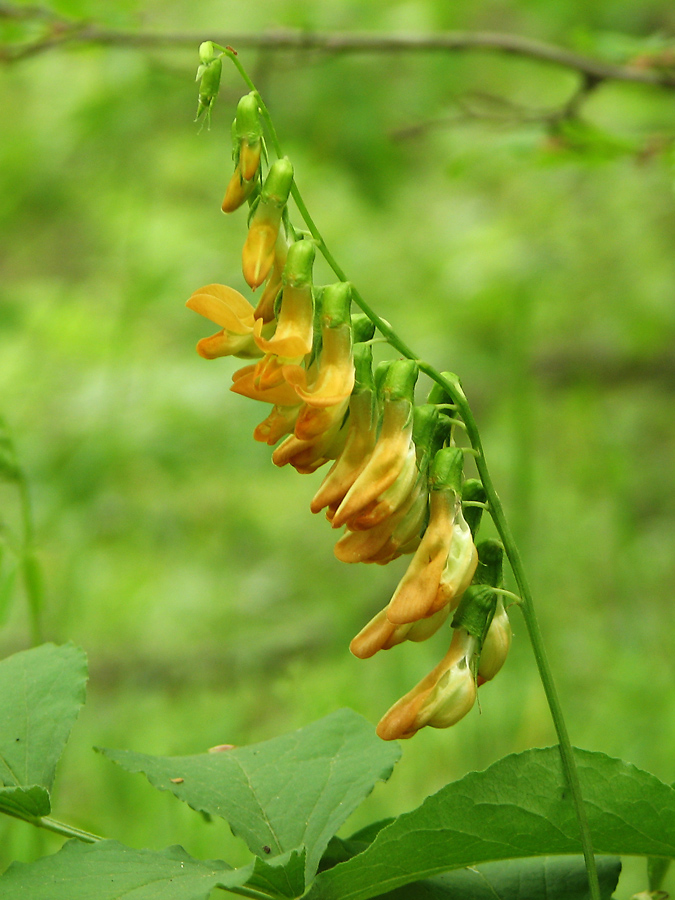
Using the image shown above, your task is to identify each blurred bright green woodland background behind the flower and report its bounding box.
[0,0,675,889]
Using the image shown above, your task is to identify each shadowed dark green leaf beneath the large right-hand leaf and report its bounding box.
[381,856,621,900]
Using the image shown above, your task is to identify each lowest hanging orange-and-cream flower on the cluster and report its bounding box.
[377,628,477,741]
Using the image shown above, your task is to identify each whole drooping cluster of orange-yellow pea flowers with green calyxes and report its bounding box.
[187,93,511,740]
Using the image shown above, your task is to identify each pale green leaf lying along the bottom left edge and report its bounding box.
[0,841,305,900]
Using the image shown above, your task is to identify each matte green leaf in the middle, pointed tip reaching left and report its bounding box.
[101,709,400,880]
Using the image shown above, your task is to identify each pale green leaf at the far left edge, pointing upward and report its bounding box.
[0,644,87,790]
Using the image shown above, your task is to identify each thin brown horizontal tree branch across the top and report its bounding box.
[0,3,675,88]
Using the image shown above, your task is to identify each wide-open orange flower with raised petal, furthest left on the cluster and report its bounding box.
[186,284,262,359]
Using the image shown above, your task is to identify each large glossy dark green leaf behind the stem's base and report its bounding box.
[308,747,675,900]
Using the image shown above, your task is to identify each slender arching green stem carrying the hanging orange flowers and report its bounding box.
[224,50,601,900]
